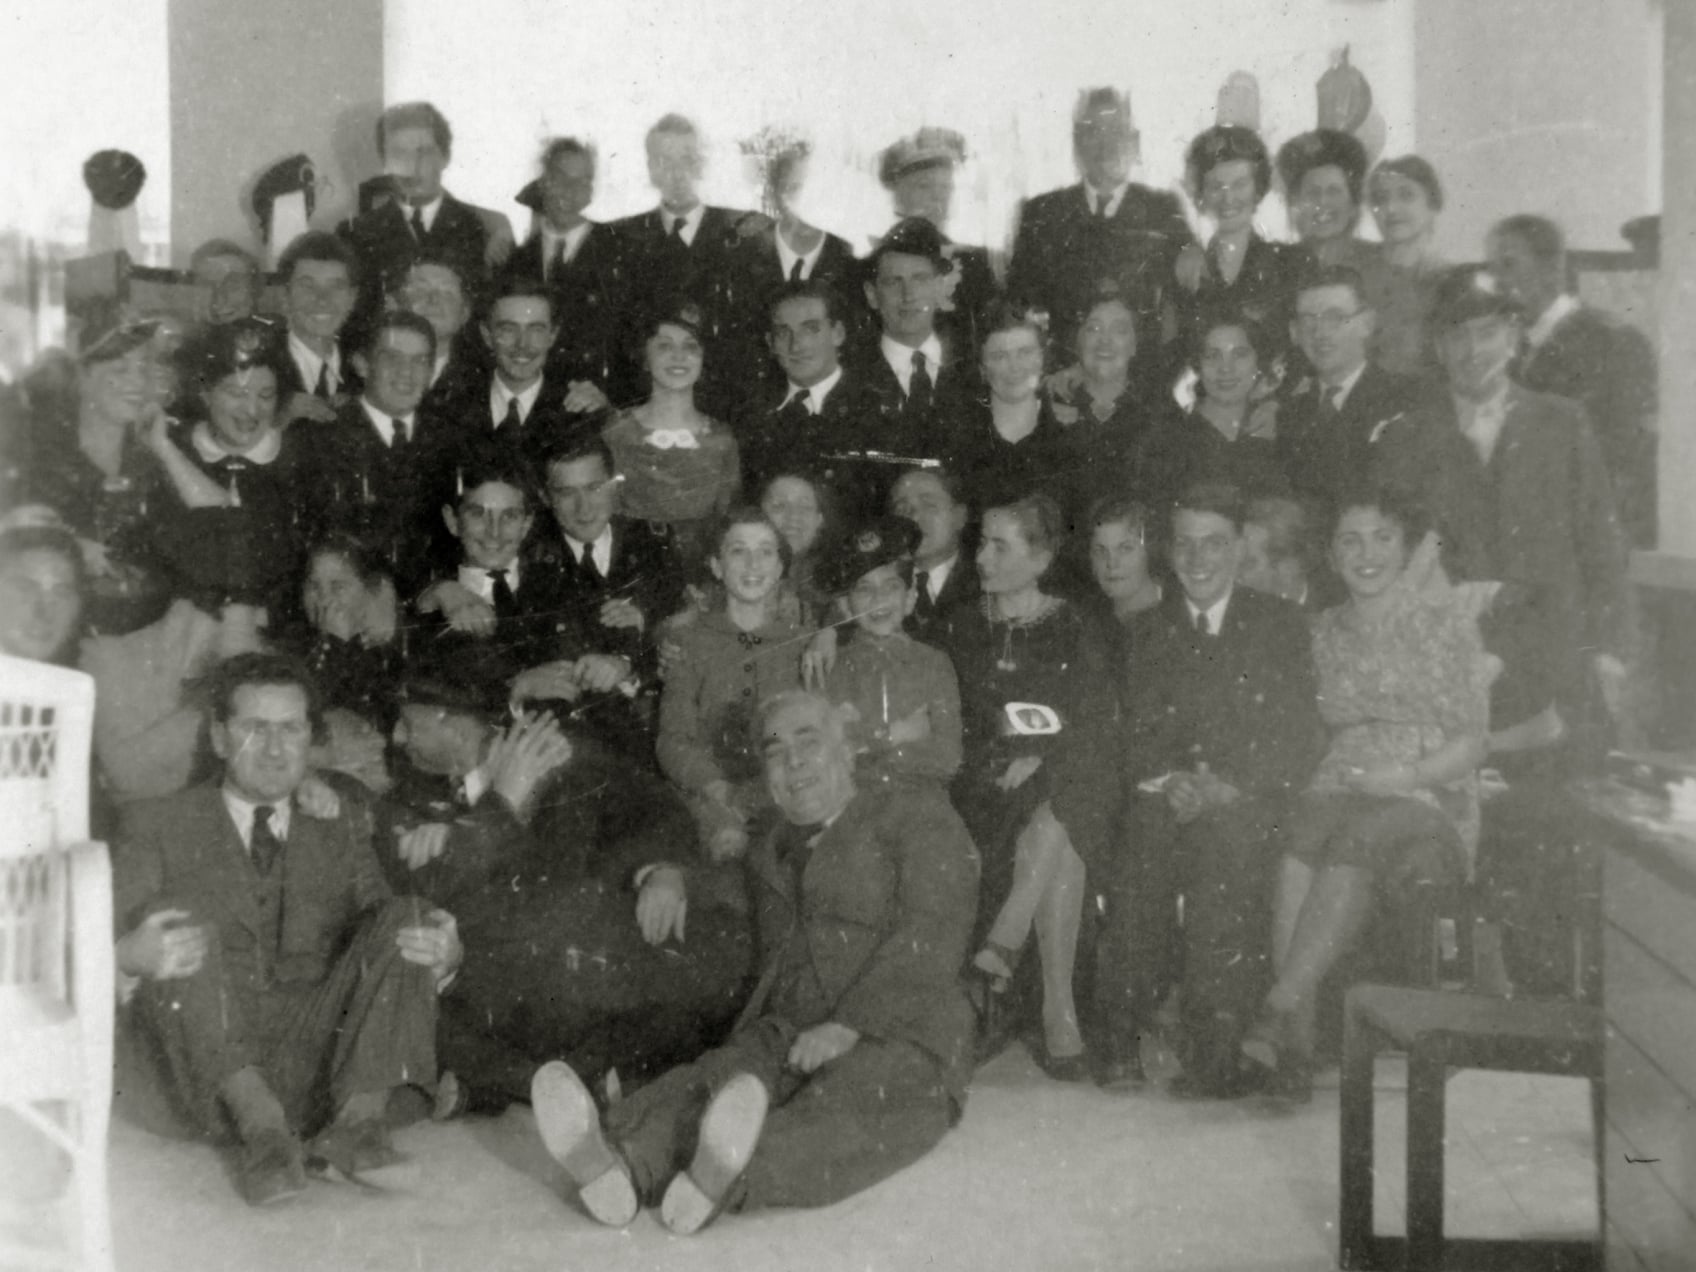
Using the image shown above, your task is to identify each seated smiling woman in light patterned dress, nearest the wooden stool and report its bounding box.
[1243,488,1489,1099]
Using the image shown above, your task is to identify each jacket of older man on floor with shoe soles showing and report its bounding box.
[743,789,979,1099]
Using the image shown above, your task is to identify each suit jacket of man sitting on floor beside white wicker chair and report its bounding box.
[112,782,390,989]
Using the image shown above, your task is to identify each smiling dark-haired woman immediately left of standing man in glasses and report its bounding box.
[1135,309,1289,507]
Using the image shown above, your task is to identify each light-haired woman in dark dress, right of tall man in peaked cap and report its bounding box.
[953,300,1072,507]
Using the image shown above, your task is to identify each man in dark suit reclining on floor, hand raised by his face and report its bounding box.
[377,678,753,1114]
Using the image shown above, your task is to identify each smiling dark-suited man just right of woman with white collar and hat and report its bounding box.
[283,310,453,595]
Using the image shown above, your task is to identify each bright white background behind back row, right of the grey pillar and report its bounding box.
[385,0,1414,256]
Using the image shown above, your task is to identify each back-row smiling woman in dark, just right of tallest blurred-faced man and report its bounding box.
[1174,126,1311,381]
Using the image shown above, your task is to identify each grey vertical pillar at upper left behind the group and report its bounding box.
[170,0,383,265]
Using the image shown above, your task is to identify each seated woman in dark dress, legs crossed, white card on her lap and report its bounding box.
[948,495,1118,1082]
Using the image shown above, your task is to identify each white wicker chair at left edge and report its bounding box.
[0,656,114,1269]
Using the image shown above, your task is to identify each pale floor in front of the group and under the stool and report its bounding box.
[69,1050,1596,1272]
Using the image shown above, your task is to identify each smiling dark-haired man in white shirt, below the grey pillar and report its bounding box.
[276,231,360,424]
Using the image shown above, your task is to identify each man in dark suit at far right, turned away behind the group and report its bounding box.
[1487,215,1657,546]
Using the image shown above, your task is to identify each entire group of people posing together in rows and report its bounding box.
[0,88,1654,1231]
